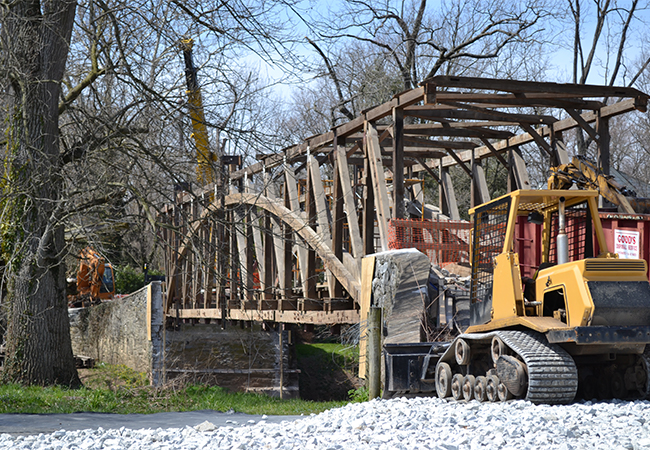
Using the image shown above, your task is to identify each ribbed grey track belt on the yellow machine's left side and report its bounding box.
[450,330,578,404]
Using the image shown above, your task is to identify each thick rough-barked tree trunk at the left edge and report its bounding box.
[0,0,80,387]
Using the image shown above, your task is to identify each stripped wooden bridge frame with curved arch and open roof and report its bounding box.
[160,76,648,325]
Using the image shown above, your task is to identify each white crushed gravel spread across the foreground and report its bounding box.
[0,398,650,450]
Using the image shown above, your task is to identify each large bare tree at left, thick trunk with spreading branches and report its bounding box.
[0,0,302,386]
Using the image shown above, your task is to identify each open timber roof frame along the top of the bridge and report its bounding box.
[225,76,648,188]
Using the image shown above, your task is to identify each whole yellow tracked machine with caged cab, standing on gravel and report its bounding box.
[432,190,650,403]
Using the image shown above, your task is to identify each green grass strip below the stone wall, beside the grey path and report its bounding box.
[0,364,347,415]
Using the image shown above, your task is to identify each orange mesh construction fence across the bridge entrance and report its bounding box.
[388,219,472,267]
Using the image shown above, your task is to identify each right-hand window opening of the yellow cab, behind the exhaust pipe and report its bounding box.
[547,201,594,263]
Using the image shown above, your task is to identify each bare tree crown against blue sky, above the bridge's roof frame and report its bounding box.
[308,0,548,89]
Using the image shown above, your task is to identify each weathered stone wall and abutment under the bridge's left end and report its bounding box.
[69,282,298,398]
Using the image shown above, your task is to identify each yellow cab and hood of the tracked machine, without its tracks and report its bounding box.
[466,190,648,351]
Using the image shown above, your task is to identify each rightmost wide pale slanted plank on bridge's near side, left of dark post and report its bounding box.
[366,122,390,251]
